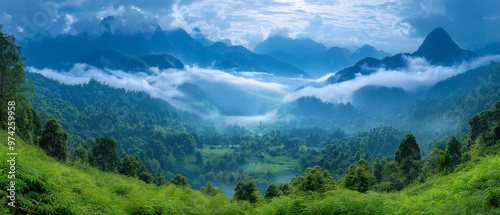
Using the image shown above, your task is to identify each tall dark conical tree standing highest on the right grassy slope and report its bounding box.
[395,133,421,184]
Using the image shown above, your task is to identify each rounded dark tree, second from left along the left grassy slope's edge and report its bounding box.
[90,136,119,172]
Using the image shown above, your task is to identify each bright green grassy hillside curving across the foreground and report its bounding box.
[0,130,500,214]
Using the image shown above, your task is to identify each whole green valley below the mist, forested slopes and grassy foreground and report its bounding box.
[0,22,500,214]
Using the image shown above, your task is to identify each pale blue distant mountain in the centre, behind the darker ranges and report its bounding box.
[254,36,390,77]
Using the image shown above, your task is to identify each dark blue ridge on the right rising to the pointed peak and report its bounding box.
[324,28,478,84]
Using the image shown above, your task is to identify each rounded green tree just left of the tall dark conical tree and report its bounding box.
[344,158,377,193]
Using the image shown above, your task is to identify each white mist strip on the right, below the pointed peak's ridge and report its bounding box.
[285,55,500,103]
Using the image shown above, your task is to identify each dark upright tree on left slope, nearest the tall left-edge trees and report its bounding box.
[39,119,68,161]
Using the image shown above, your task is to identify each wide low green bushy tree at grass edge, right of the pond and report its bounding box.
[290,166,334,192]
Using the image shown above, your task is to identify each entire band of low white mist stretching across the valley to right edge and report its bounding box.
[28,56,500,124]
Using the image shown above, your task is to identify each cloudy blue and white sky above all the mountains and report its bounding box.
[0,0,500,53]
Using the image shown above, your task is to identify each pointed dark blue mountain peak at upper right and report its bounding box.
[412,27,477,66]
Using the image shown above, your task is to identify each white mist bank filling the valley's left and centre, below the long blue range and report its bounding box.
[28,64,296,123]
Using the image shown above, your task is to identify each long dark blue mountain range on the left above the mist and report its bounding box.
[21,27,310,77]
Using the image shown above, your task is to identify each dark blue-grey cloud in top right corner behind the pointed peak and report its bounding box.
[400,0,500,49]
